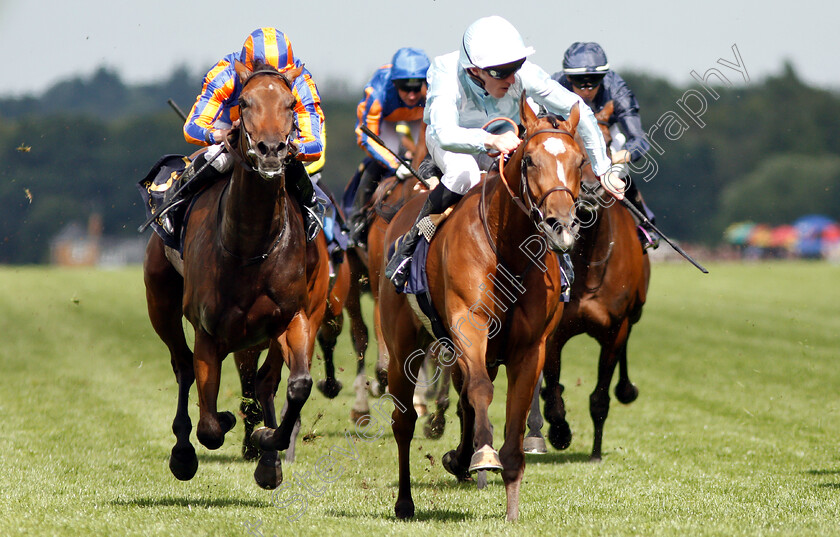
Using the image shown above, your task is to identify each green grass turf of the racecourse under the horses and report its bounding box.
[0,263,840,537]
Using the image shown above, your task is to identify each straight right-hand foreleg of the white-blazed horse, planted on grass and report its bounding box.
[499,342,545,521]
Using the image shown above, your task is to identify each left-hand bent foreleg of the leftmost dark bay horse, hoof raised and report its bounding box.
[193,329,236,449]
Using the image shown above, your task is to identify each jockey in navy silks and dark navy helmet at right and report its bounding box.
[552,42,659,250]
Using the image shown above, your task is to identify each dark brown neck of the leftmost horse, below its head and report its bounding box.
[221,168,286,257]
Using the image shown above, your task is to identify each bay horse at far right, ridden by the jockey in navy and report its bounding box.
[528,101,650,461]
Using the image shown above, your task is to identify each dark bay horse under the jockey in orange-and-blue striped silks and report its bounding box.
[143,62,329,488]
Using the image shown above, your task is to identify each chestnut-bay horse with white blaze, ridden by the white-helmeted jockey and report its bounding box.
[378,93,584,520]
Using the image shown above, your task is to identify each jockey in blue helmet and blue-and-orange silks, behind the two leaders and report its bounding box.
[351,47,429,244]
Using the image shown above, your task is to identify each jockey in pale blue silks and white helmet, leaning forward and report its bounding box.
[385,16,624,290]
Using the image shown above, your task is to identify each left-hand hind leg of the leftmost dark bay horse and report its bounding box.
[143,235,198,481]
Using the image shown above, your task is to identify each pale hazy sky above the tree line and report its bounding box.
[0,0,840,96]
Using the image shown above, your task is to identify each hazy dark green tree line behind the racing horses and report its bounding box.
[0,65,840,263]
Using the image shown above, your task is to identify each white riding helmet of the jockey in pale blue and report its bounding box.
[461,15,534,69]
